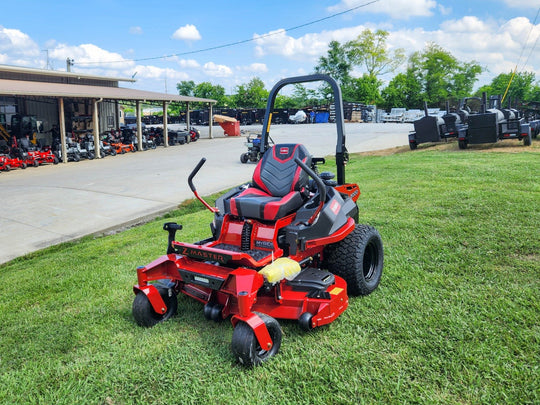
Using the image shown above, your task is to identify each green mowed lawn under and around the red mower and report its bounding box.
[0,143,540,404]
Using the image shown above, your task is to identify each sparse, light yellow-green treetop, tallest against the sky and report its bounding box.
[344,28,406,77]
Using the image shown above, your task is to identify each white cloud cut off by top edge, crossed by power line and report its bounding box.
[328,0,436,20]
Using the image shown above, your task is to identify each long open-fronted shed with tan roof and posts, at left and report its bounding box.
[0,65,216,161]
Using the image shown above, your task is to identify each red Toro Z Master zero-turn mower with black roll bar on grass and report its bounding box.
[133,75,383,366]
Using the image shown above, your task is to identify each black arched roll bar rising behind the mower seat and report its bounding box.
[261,74,347,185]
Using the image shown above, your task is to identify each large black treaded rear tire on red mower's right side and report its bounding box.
[324,225,384,296]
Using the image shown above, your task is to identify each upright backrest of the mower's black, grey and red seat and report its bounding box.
[253,144,311,197]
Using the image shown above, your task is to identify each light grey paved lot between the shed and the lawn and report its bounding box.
[0,123,412,264]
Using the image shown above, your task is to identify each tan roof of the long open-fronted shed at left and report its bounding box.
[0,65,216,103]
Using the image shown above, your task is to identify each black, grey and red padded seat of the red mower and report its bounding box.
[230,144,311,221]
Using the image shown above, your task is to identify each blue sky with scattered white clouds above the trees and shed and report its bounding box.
[0,0,540,93]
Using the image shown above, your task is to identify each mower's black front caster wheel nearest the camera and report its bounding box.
[231,313,282,367]
